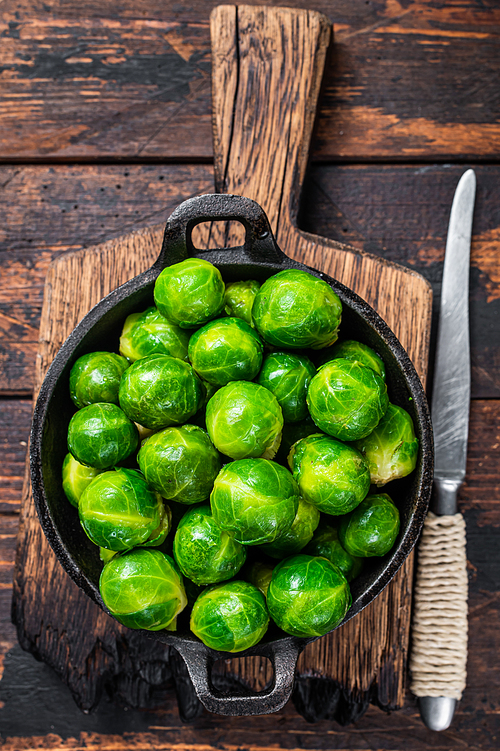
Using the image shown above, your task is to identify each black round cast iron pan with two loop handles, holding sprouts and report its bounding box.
[30,194,432,715]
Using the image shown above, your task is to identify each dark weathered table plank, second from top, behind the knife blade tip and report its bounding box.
[0,165,500,398]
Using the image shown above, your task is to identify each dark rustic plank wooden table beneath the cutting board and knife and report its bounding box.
[0,0,500,751]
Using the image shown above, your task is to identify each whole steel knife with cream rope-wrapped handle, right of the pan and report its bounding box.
[410,169,476,730]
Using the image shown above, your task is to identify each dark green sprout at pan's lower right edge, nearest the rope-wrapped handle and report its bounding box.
[339,493,399,558]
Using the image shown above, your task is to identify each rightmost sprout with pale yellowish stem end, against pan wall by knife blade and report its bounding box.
[354,404,418,487]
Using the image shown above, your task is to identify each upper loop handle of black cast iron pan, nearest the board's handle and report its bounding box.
[153,193,289,271]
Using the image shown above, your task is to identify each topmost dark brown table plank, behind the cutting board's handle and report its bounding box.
[0,0,500,160]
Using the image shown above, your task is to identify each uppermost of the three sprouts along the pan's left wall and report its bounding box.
[69,352,129,408]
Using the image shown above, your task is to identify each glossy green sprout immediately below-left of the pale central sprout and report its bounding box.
[137,425,221,503]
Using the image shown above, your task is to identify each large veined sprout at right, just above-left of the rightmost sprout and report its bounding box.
[306,357,389,441]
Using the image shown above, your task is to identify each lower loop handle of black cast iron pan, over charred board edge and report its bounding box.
[175,639,301,716]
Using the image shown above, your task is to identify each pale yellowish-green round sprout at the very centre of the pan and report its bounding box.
[206,381,283,459]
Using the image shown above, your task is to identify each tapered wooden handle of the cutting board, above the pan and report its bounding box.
[210,5,332,235]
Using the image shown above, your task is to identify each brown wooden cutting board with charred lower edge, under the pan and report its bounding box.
[13,5,432,722]
